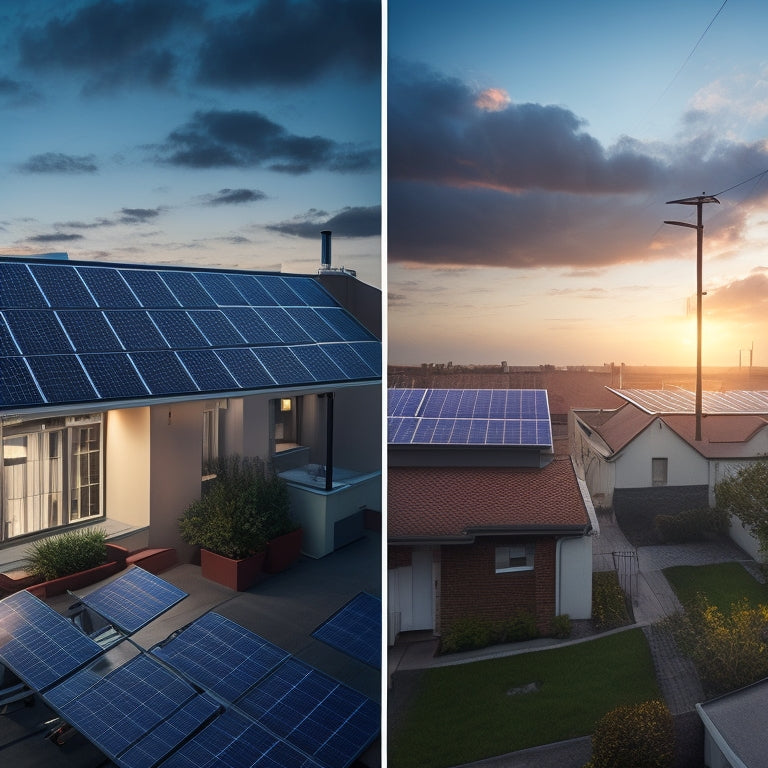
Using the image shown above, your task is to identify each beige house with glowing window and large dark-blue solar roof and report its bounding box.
[0,257,381,559]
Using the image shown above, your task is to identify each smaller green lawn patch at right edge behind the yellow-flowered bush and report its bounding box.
[663,563,768,611]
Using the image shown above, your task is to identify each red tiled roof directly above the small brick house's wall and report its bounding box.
[387,456,589,541]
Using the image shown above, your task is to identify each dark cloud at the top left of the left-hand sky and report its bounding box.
[19,0,202,91]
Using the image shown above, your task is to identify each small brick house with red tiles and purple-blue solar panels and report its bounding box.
[387,390,597,642]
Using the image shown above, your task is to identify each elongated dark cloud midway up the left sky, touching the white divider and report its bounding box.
[161,110,379,174]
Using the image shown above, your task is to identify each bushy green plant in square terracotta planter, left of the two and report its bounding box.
[179,456,266,591]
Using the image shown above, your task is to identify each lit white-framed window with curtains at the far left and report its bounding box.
[0,416,103,540]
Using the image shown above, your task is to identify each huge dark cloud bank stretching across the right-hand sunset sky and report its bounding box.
[388,65,768,269]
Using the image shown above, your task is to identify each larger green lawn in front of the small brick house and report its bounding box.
[389,629,661,768]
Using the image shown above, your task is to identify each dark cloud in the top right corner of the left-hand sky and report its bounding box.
[198,0,381,87]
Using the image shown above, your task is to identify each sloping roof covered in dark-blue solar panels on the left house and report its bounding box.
[0,257,381,413]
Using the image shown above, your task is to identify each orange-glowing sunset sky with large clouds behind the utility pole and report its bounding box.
[387,0,768,366]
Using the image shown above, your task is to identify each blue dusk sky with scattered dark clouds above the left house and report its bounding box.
[0,0,381,285]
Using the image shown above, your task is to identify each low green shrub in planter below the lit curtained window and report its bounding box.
[24,528,107,581]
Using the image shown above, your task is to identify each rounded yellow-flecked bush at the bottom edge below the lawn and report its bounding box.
[589,700,675,768]
